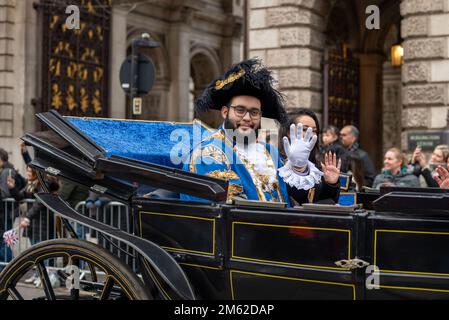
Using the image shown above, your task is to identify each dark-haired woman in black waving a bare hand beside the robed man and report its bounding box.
[279,108,341,205]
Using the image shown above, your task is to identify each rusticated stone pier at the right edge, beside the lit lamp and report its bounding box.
[401,0,449,149]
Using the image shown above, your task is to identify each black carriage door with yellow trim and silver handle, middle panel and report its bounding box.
[227,209,358,300]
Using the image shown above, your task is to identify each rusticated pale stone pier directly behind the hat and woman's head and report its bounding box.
[248,0,328,114]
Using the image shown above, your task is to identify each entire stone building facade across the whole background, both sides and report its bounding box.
[0,0,449,174]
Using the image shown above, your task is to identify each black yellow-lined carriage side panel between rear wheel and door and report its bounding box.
[134,199,228,299]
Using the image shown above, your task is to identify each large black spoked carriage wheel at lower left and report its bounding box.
[0,239,151,300]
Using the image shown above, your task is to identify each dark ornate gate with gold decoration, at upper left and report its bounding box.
[39,0,111,117]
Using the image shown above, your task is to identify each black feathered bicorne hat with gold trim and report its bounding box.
[195,59,286,123]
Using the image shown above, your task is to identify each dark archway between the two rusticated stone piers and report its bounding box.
[323,0,401,169]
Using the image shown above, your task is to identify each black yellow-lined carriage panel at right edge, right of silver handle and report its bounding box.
[366,213,449,299]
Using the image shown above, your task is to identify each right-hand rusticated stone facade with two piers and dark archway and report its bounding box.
[247,0,449,168]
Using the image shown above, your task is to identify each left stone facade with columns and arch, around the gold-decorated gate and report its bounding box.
[0,0,244,173]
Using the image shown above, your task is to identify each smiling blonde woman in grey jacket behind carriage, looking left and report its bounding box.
[373,148,419,189]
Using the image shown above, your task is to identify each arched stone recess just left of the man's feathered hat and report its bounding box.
[189,45,222,128]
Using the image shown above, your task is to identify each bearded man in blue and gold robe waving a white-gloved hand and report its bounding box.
[181,59,338,205]
